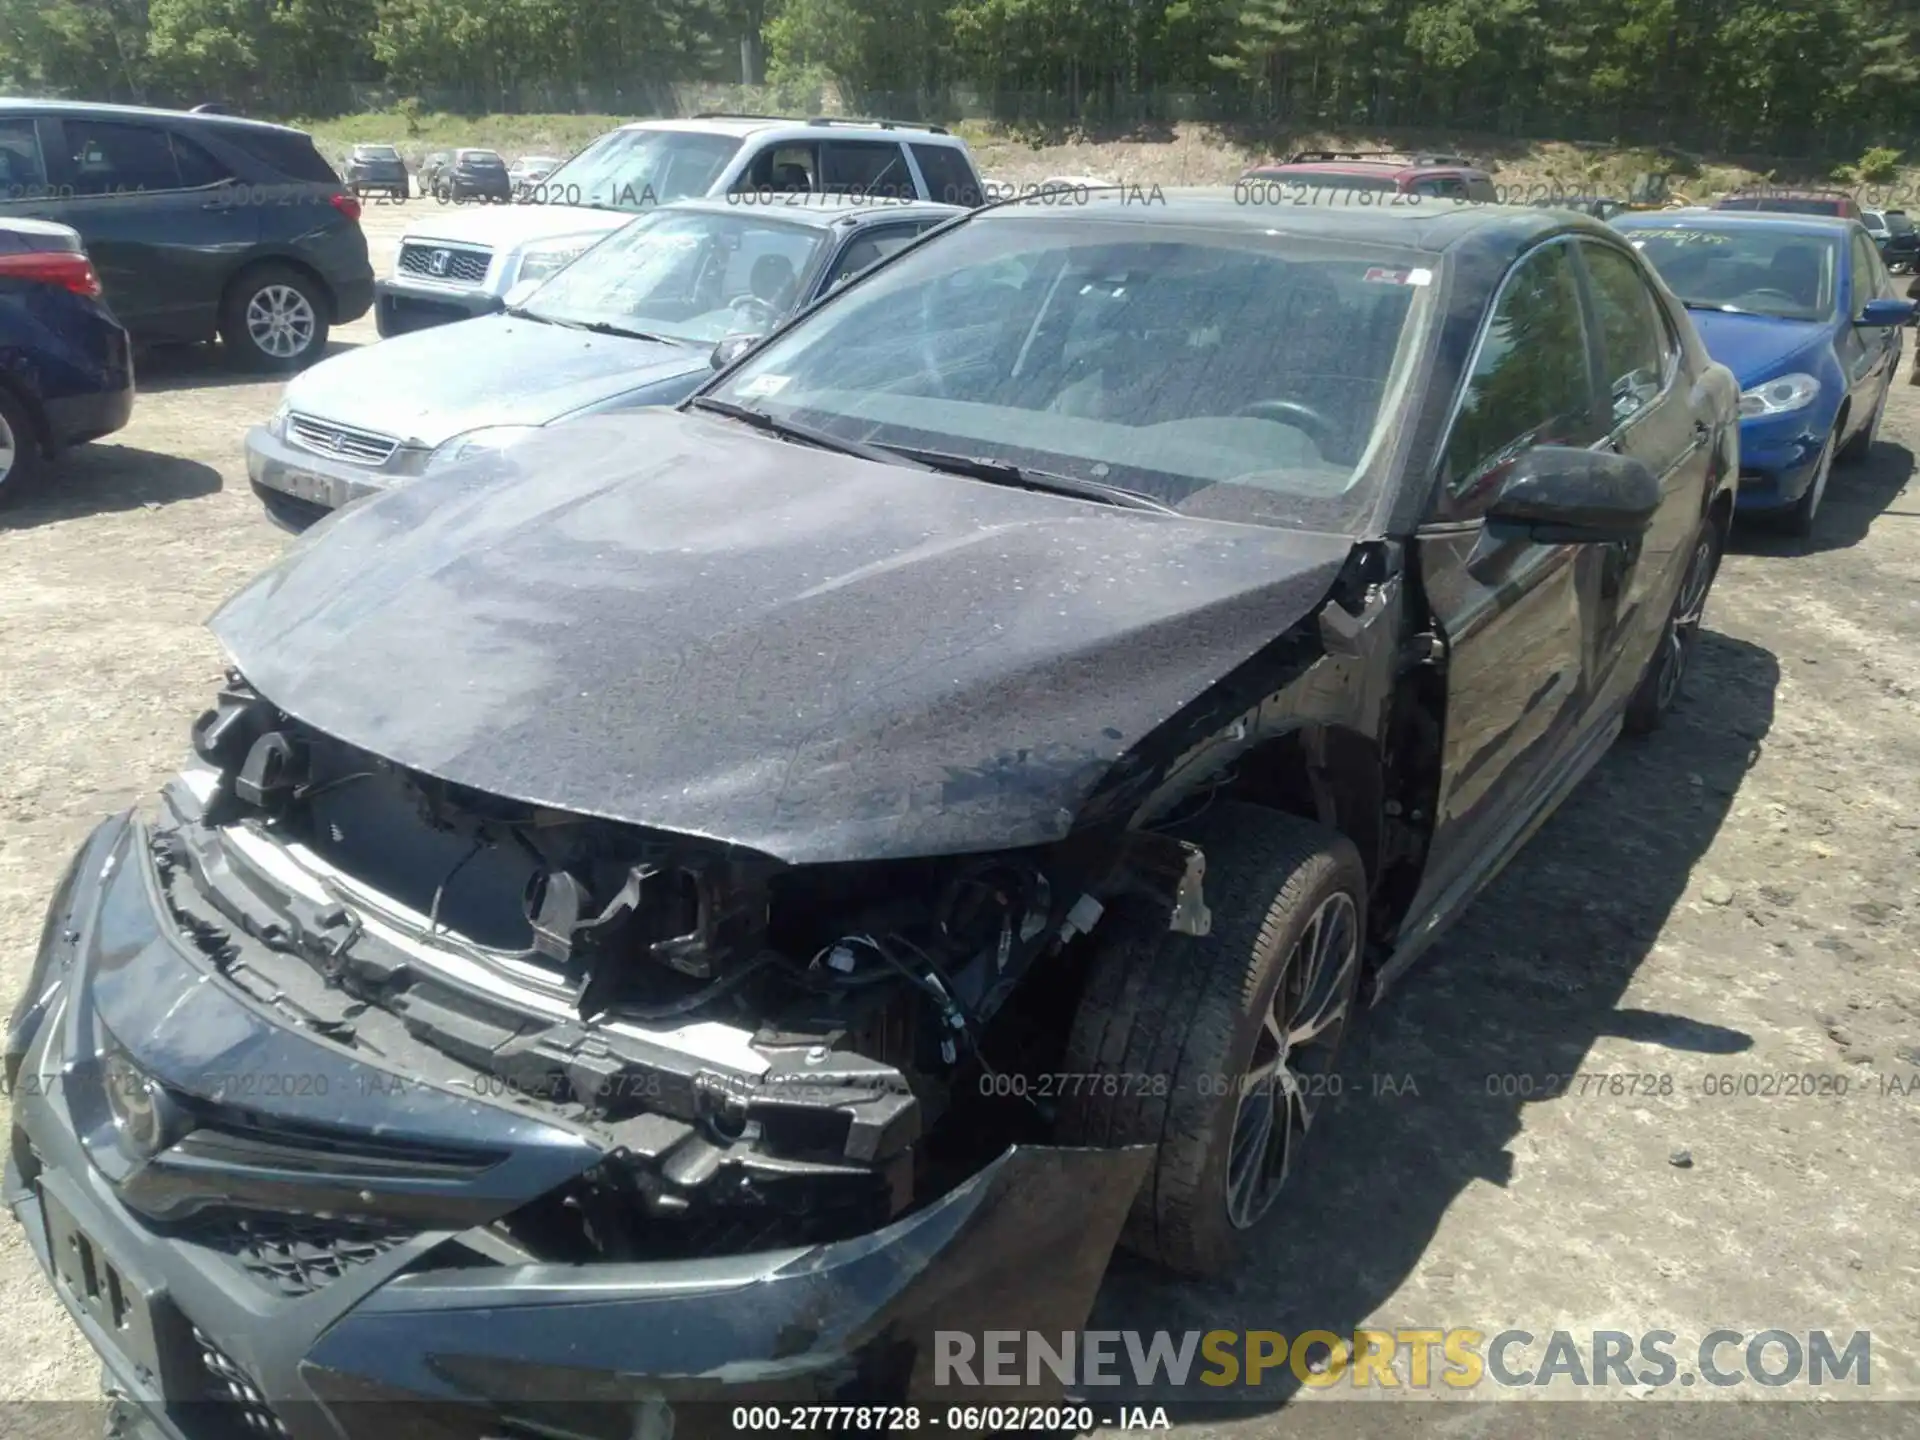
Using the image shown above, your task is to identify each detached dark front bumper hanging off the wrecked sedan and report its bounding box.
[4,816,1150,1440]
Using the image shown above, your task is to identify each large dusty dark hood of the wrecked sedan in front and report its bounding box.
[211,411,1352,864]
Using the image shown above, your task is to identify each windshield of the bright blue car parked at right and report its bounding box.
[1628,225,1839,321]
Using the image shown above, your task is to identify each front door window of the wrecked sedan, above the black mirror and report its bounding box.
[1440,244,1605,516]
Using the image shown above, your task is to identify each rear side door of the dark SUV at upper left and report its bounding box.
[48,115,261,340]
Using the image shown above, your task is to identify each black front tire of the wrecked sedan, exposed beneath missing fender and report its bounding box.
[1058,801,1367,1277]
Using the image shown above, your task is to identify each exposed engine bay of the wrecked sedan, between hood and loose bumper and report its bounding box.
[152,672,1208,1260]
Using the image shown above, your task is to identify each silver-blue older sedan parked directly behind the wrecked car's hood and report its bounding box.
[246,196,964,530]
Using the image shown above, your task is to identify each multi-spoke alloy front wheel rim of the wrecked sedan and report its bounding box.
[1227,891,1359,1229]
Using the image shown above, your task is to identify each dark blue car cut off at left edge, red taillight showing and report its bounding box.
[0,219,132,505]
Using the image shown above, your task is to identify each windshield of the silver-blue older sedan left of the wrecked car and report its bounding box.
[520,207,828,344]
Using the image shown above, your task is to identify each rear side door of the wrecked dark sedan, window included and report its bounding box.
[1574,238,1715,710]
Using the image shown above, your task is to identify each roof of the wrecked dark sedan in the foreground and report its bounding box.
[975,186,1620,261]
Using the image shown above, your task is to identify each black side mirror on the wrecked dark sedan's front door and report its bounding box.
[1486,445,1661,545]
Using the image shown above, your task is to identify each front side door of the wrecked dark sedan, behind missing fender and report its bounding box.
[1409,238,1615,924]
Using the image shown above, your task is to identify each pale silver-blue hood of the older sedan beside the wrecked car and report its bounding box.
[286,315,710,449]
